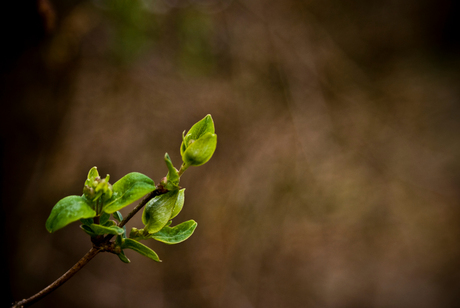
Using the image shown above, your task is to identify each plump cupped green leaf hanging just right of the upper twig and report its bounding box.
[142,190,179,233]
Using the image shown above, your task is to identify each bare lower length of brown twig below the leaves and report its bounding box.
[11,247,100,308]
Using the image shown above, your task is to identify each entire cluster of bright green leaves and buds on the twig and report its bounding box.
[46,115,217,263]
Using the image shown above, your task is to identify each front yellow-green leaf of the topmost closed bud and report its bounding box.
[182,133,217,166]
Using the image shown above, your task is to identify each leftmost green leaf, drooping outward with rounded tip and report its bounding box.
[46,196,96,233]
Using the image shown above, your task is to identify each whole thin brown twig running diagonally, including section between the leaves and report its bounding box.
[11,185,168,308]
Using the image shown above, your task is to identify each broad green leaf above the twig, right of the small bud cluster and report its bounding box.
[103,172,155,213]
